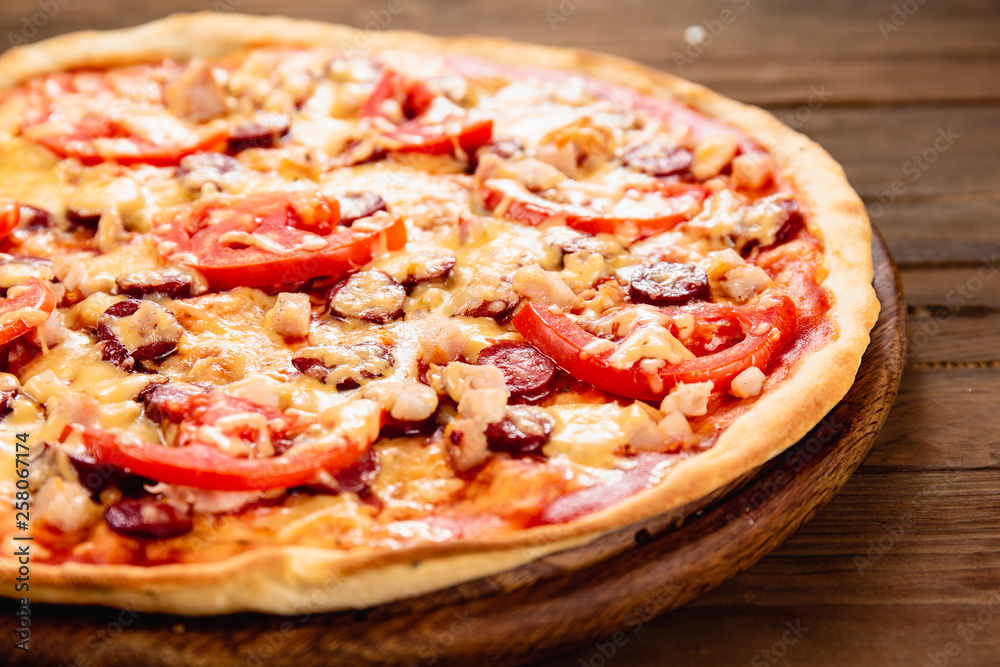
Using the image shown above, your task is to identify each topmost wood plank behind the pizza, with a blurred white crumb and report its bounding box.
[0,0,1000,105]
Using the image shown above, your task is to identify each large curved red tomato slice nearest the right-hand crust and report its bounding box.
[513,296,796,400]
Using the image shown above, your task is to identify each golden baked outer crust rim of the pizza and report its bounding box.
[0,13,879,615]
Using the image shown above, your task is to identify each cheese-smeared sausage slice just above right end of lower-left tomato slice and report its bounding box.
[292,343,395,389]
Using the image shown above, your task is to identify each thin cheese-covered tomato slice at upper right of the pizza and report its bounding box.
[480,179,708,241]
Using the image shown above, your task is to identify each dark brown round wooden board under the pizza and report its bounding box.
[0,231,906,667]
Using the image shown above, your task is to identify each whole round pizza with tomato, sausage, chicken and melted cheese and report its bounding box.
[0,14,878,615]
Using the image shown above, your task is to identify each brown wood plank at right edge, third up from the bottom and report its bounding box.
[861,368,1000,472]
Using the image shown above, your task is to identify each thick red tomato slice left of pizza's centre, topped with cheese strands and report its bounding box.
[154,192,406,291]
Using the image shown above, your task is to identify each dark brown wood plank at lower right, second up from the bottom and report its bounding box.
[693,468,1000,606]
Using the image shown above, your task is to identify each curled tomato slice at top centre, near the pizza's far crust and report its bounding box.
[361,70,493,155]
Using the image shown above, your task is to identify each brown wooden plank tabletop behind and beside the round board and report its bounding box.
[0,0,1000,667]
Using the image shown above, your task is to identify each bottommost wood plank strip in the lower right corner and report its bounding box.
[538,594,1000,667]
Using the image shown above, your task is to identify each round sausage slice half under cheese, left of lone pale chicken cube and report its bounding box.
[97,299,184,368]
